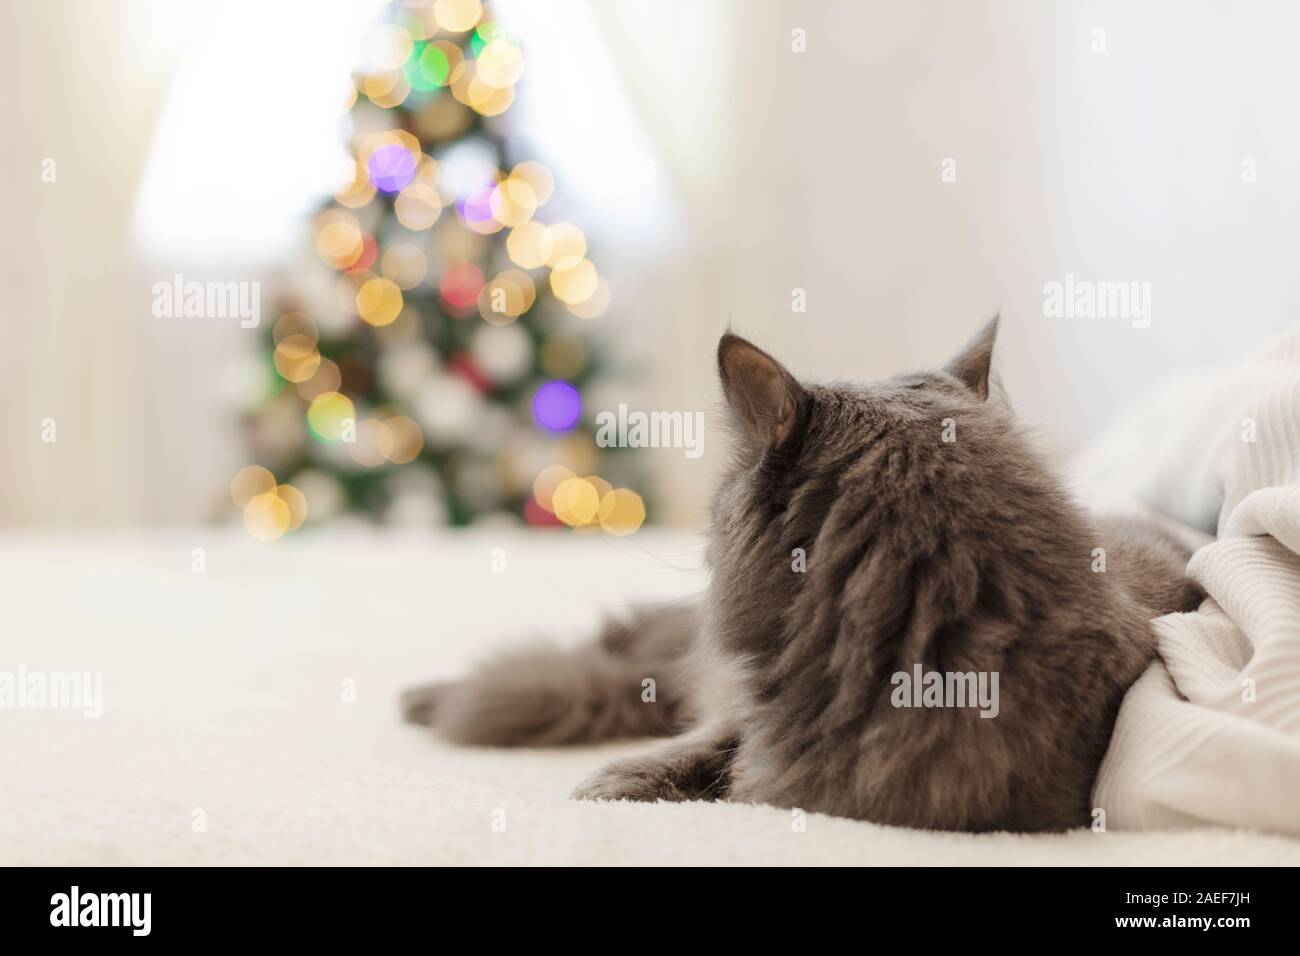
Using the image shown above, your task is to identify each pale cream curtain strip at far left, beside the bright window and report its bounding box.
[0,0,200,525]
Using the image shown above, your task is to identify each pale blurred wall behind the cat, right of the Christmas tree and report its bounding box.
[607,1,1300,522]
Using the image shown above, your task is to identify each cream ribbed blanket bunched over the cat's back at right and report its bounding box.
[1079,327,1300,835]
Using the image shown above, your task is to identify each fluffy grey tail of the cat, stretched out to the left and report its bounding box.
[402,605,697,747]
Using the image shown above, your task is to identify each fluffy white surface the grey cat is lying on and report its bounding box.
[0,529,1300,865]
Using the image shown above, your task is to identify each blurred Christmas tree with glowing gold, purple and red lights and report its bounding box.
[231,0,645,538]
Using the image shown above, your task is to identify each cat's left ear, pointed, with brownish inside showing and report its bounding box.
[718,332,807,447]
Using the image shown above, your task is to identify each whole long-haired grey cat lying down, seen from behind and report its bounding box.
[403,320,1200,831]
